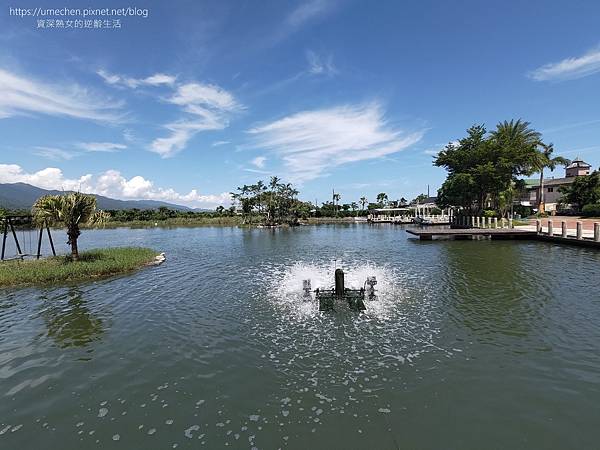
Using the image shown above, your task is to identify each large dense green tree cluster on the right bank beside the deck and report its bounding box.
[433,120,569,217]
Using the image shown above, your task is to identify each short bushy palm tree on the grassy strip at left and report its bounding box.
[33,192,109,261]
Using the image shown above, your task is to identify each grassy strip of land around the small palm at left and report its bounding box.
[0,247,158,287]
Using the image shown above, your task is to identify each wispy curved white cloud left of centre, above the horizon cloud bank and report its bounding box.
[150,83,243,158]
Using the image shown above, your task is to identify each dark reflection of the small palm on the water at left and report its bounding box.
[41,288,104,348]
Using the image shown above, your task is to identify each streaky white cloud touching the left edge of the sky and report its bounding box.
[0,69,122,122]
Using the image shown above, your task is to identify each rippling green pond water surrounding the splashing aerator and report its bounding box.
[0,224,600,449]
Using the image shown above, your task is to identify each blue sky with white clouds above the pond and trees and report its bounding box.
[0,0,600,207]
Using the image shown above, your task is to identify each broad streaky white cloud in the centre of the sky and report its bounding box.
[249,103,423,182]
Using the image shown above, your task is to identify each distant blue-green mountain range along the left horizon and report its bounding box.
[0,183,193,211]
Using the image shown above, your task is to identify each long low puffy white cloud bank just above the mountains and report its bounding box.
[0,164,231,208]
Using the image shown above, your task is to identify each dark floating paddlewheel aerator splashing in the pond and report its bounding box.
[302,269,377,311]
